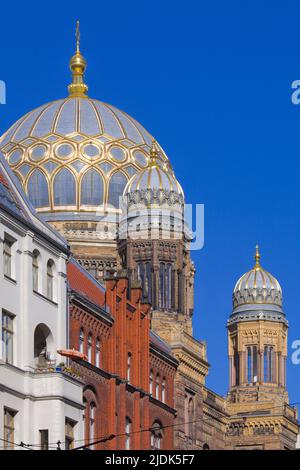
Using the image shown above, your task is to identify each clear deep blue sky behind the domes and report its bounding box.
[0,0,300,402]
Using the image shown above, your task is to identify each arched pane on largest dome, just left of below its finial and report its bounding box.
[53,168,76,206]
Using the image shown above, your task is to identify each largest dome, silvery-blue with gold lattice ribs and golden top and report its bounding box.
[0,35,174,219]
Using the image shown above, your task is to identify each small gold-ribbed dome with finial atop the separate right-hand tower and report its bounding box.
[233,246,282,307]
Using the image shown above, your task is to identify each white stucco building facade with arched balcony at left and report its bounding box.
[0,168,83,449]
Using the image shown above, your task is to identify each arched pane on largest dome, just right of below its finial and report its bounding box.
[81,169,103,206]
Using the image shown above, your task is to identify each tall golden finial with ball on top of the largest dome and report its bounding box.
[68,21,88,98]
